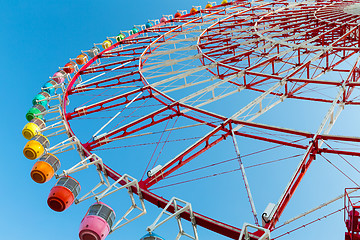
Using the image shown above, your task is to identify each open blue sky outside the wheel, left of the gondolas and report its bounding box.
[0,0,229,240]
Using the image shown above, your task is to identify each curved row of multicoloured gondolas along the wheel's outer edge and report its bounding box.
[22,0,227,240]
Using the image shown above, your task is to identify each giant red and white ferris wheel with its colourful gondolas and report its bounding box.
[23,0,360,240]
